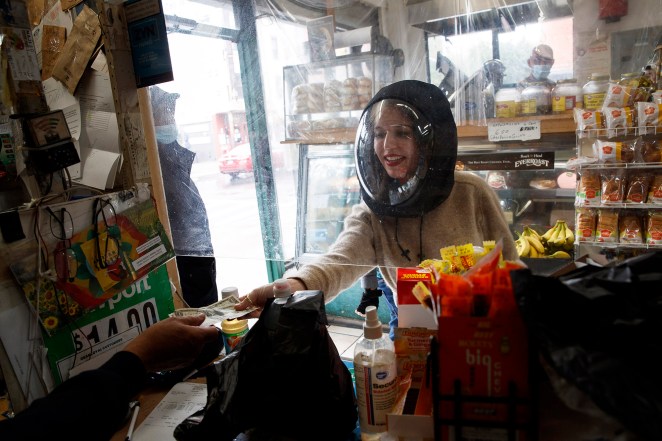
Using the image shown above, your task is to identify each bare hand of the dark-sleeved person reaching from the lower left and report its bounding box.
[124,314,219,372]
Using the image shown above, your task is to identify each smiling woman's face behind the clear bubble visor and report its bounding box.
[374,104,418,183]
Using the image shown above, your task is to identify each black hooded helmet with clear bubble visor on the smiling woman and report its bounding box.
[355,80,457,217]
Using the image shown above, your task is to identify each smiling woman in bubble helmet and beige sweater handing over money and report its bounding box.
[235,80,517,324]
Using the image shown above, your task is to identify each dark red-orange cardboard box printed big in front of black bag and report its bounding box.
[437,314,531,441]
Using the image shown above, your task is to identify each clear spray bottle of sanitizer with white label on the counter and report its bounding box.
[354,306,398,441]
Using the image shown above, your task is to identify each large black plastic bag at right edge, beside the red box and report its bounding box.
[511,252,662,440]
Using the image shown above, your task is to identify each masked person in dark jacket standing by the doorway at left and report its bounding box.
[150,86,218,307]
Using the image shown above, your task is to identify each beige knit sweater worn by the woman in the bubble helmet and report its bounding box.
[286,172,517,302]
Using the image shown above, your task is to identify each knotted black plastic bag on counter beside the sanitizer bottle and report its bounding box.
[175,291,358,441]
